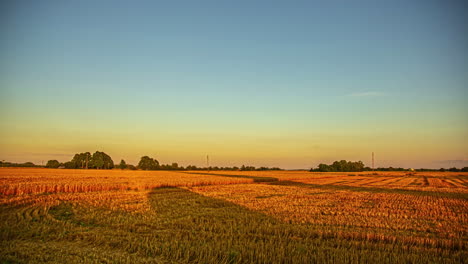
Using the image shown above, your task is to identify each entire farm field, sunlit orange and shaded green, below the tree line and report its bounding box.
[0,168,468,263]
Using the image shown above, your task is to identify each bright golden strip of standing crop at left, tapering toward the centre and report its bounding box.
[0,168,253,195]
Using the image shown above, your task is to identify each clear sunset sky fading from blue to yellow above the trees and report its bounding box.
[0,0,468,169]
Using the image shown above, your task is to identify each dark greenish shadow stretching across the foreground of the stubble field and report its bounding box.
[0,187,466,264]
